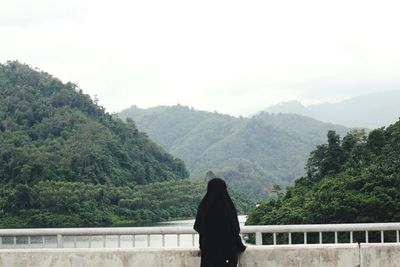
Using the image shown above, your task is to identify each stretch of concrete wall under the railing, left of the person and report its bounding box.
[0,248,200,267]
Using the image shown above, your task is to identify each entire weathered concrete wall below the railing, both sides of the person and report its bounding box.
[0,244,400,267]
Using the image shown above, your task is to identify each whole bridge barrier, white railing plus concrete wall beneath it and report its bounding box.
[0,223,400,267]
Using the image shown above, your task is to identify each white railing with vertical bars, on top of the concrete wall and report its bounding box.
[0,223,400,248]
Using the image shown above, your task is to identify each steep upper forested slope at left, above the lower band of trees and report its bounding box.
[0,62,188,185]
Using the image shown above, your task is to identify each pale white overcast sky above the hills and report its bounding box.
[0,0,400,115]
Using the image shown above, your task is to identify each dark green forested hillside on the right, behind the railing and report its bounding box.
[247,121,400,227]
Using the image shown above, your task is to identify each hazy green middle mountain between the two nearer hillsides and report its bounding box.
[119,105,348,199]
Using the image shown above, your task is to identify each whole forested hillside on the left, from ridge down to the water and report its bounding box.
[0,62,249,227]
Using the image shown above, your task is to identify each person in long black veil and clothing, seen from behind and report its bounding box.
[194,178,246,267]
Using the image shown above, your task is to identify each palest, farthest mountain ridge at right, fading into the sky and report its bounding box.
[265,90,400,129]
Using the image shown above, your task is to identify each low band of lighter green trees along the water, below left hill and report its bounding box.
[0,180,252,227]
